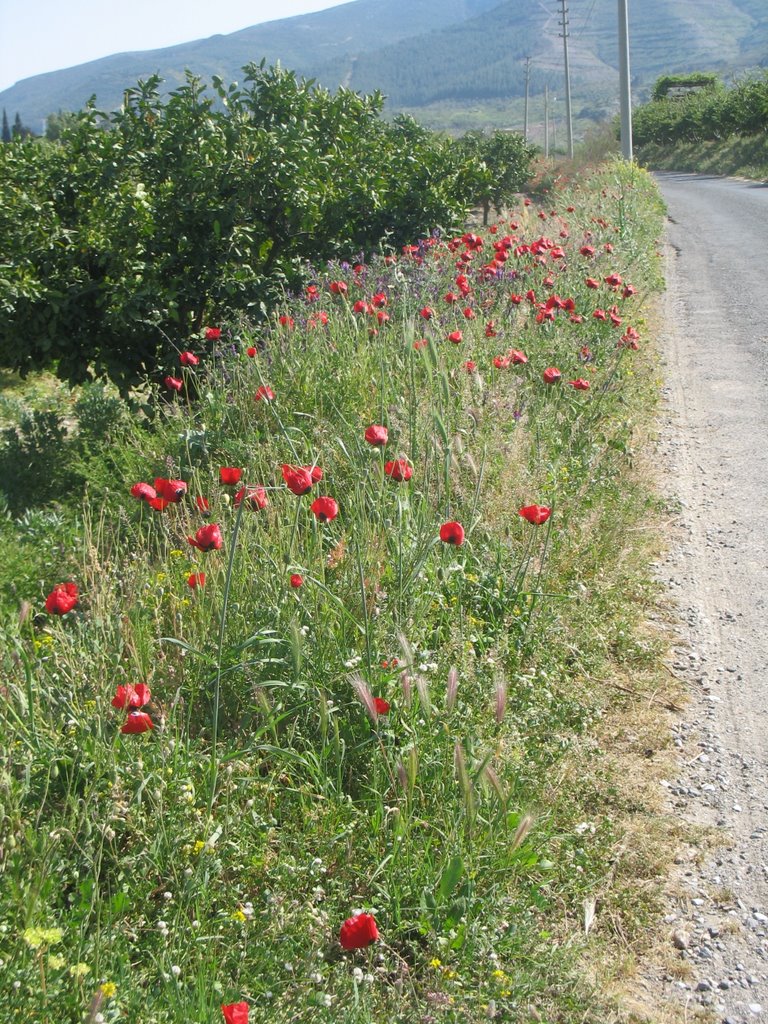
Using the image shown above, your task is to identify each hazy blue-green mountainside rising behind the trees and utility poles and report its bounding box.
[0,0,768,130]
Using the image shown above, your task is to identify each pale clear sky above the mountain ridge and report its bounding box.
[0,0,345,90]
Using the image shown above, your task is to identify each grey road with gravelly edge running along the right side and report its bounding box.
[655,174,768,1024]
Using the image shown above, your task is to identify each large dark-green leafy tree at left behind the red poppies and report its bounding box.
[0,62,481,388]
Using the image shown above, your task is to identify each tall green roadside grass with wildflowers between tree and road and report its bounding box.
[0,159,660,1024]
